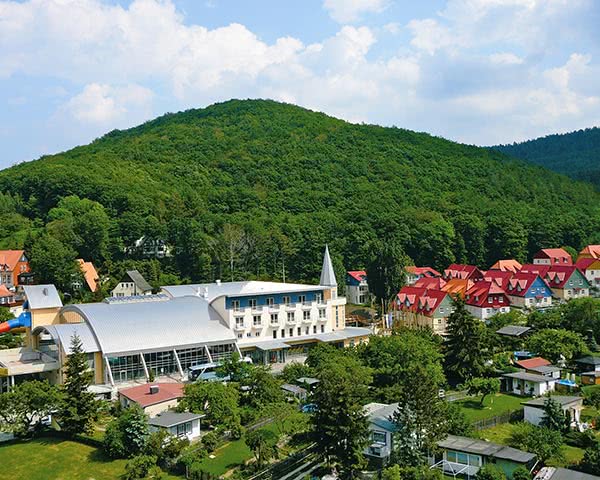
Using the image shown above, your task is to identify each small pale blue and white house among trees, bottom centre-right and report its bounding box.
[364,403,398,467]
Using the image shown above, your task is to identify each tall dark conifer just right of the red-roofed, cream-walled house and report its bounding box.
[445,297,490,381]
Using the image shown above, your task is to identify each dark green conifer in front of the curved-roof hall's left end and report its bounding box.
[59,335,98,435]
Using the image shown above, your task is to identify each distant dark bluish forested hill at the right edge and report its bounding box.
[493,127,600,190]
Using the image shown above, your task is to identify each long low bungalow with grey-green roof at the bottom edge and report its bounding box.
[429,435,537,479]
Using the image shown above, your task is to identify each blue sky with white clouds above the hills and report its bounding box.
[0,0,600,168]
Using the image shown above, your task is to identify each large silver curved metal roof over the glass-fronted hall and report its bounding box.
[62,296,236,355]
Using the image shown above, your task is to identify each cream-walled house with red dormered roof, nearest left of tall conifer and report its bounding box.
[396,287,454,335]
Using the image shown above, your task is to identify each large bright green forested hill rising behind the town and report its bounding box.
[0,100,600,288]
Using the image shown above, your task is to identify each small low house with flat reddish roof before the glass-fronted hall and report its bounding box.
[119,383,184,416]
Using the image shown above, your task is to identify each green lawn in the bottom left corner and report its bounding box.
[0,438,181,480]
